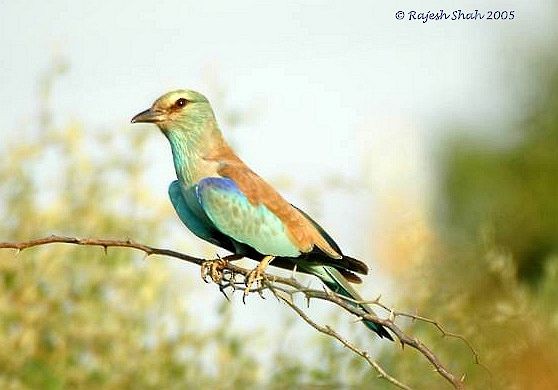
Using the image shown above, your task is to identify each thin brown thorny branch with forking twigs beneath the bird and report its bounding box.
[0,235,480,389]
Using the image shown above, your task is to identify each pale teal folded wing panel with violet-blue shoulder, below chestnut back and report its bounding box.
[197,177,301,257]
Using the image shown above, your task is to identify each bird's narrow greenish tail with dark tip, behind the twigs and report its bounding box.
[308,265,393,341]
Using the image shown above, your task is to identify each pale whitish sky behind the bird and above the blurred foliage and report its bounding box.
[0,0,556,362]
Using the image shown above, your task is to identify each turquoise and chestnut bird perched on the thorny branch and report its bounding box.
[131,89,393,340]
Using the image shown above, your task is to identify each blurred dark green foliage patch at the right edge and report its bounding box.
[441,74,558,285]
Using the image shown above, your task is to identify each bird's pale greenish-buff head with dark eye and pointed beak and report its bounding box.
[132,89,215,131]
